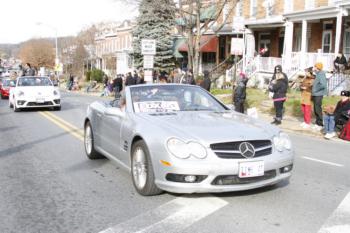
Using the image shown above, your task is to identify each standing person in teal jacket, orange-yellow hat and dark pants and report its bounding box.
[312,62,327,131]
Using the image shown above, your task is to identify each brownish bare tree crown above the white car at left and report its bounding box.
[19,39,55,68]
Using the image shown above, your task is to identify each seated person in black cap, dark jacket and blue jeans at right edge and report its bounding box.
[323,91,350,139]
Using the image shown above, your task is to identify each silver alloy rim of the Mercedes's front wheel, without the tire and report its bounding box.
[132,147,147,189]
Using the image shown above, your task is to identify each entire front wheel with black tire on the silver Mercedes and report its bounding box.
[131,140,162,196]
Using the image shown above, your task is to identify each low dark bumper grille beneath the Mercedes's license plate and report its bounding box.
[211,170,276,185]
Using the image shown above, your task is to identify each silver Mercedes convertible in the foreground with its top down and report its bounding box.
[84,84,294,195]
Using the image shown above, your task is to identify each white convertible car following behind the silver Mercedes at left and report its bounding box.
[9,76,61,112]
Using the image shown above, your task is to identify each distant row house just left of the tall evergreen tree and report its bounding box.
[95,20,134,76]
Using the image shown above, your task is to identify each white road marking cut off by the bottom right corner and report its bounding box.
[318,192,350,233]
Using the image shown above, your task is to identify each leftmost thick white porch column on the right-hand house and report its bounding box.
[282,22,294,71]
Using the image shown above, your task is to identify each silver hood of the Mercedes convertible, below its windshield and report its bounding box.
[135,111,280,145]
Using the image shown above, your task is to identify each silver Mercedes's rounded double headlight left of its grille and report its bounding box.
[166,138,207,159]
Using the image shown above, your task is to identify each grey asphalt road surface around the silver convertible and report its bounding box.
[0,93,350,233]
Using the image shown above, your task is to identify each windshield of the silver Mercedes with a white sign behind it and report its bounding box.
[130,85,228,113]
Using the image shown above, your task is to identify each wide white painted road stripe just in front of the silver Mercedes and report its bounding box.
[99,196,228,233]
